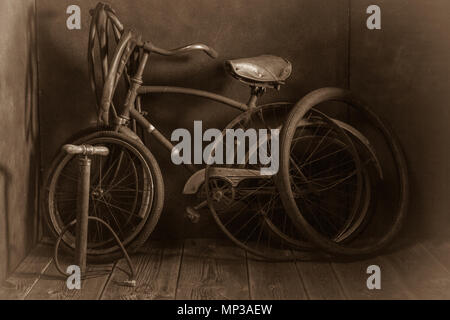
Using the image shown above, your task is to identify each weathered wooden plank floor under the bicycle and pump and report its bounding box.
[0,239,450,300]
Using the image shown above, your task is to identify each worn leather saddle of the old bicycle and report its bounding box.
[225,55,292,87]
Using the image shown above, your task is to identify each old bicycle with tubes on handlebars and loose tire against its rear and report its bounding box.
[43,3,408,262]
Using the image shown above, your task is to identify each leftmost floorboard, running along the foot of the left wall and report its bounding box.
[0,244,53,300]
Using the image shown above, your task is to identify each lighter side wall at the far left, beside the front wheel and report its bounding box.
[0,0,39,282]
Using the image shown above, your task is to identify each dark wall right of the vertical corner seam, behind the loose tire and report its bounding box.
[350,0,450,236]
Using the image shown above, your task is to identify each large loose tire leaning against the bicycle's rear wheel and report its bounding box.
[279,88,409,256]
